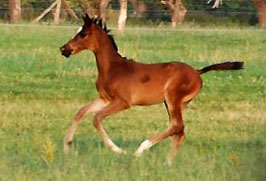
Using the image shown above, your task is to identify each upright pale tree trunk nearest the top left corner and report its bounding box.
[9,0,21,23]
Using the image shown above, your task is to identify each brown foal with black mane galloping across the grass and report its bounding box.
[60,14,243,163]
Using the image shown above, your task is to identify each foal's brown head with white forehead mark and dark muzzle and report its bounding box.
[60,14,113,57]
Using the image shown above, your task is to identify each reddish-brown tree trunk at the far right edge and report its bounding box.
[252,0,266,28]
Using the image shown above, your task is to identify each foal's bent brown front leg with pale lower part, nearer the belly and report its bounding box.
[93,100,130,153]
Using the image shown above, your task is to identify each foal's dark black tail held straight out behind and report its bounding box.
[198,62,244,74]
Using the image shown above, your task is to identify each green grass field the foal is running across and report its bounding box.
[0,25,266,181]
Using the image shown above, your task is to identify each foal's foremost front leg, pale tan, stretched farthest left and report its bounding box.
[64,99,108,154]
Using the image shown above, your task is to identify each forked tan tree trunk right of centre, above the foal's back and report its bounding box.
[161,0,187,27]
